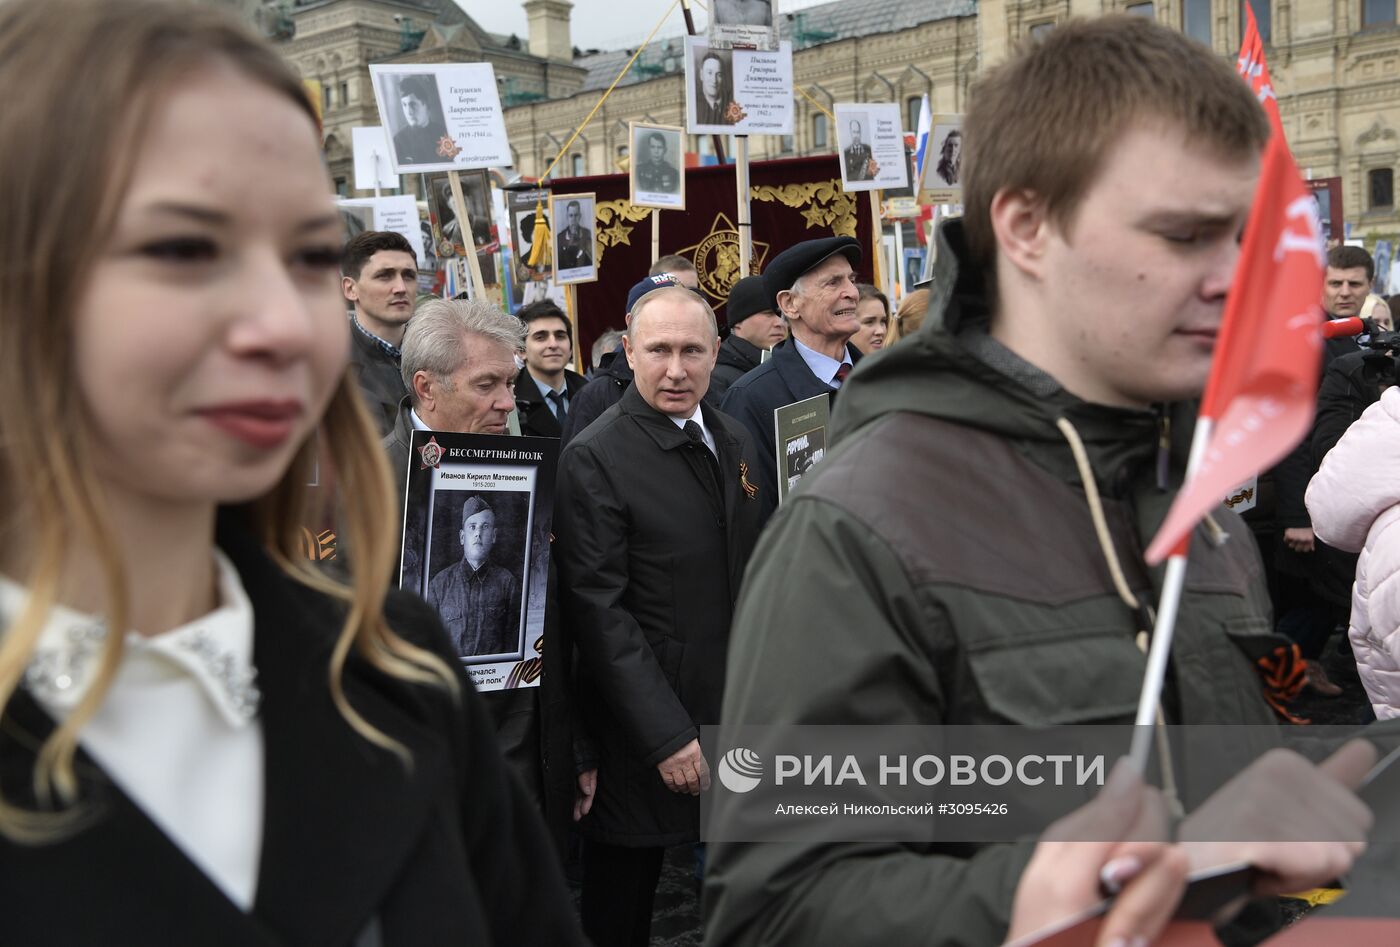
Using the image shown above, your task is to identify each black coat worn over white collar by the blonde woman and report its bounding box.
[0,518,584,947]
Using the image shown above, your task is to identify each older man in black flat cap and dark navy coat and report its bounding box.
[721,237,861,520]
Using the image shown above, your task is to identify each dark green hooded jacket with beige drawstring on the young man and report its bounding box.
[706,221,1285,947]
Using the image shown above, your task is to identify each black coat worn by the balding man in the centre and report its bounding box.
[554,388,759,846]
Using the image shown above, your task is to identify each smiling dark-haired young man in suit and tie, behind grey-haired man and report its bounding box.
[515,300,588,437]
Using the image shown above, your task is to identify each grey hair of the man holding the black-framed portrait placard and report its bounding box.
[400,298,525,406]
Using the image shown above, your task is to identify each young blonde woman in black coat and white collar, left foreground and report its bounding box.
[0,0,582,944]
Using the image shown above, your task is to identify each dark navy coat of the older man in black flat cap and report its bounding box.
[720,339,861,521]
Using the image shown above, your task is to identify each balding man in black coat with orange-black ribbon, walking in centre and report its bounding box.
[554,287,759,947]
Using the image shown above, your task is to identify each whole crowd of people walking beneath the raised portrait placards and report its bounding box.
[0,0,1400,947]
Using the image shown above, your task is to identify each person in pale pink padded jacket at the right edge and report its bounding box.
[1308,388,1400,720]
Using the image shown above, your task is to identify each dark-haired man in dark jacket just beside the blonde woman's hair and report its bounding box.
[340,230,419,437]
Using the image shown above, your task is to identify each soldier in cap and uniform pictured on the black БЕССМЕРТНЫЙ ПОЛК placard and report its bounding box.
[427,496,521,657]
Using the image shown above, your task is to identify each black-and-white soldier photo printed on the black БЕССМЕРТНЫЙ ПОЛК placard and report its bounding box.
[427,490,529,658]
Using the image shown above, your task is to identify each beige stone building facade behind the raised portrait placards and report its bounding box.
[235,0,1400,247]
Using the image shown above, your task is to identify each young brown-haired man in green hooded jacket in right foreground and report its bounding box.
[706,17,1375,946]
